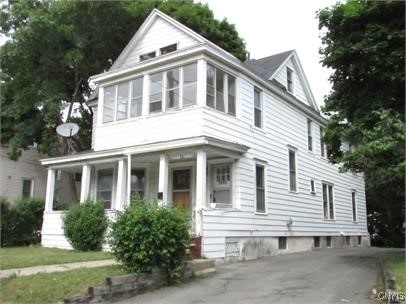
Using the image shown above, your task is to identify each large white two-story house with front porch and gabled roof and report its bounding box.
[42,10,369,258]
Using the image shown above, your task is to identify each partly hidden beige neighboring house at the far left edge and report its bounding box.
[0,146,47,203]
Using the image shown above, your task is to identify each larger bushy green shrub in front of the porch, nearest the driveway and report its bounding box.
[110,199,189,283]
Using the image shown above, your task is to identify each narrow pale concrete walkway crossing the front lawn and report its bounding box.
[0,260,117,279]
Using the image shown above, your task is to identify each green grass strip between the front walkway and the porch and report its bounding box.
[0,246,113,269]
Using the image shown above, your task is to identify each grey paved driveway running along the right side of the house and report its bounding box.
[116,248,394,304]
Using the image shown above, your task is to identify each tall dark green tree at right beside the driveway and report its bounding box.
[318,1,405,247]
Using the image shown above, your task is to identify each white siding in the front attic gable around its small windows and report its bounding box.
[117,18,198,68]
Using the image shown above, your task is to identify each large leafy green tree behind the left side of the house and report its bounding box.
[0,0,246,159]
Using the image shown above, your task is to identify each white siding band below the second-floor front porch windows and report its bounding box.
[94,107,202,151]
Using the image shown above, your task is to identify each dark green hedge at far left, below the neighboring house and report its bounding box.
[0,197,45,247]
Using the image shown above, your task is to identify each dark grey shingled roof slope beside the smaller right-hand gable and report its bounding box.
[243,50,293,80]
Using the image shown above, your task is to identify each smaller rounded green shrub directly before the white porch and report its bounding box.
[63,200,108,251]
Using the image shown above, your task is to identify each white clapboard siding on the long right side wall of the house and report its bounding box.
[203,79,367,257]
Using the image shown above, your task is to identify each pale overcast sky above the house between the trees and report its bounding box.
[200,0,337,106]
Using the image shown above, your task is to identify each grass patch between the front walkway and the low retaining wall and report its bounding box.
[0,266,125,304]
